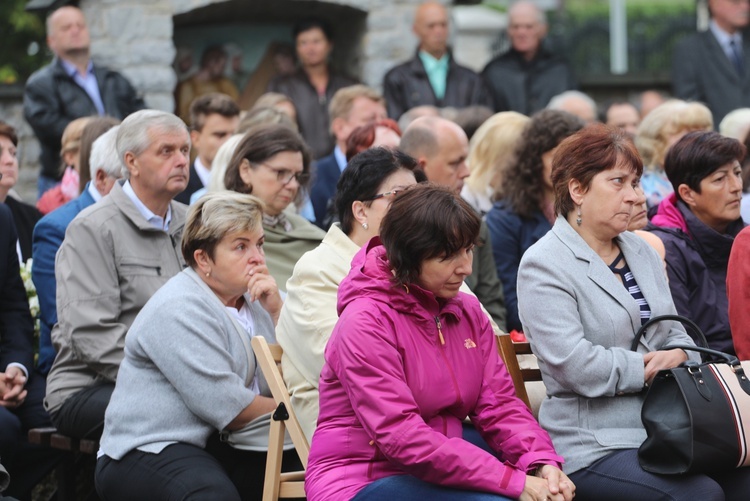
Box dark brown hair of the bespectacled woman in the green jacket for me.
[224,125,310,195]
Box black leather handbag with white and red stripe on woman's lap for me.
[631,315,750,474]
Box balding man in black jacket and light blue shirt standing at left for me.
[23,6,145,196]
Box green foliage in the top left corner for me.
[0,0,51,85]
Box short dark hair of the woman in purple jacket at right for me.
[664,131,747,200]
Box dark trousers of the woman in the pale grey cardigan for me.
[95,434,302,501]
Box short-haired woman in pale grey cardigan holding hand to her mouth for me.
[96,192,299,501]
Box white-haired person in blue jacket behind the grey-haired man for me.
[31,126,124,376]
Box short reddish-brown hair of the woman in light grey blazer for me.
[552,124,643,216]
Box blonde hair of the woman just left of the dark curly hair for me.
[466,111,531,193]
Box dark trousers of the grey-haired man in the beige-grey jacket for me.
[52,383,115,440]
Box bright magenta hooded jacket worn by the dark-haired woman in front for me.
[305,239,562,501]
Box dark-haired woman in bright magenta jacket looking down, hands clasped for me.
[305,185,575,501]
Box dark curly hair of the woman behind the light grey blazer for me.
[495,110,585,219]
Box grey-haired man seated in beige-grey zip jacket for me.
[44,110,190,438]
